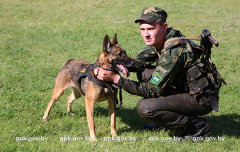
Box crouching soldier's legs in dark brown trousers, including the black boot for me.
[137,67,215,138]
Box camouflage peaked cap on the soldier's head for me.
[135,7,167,23]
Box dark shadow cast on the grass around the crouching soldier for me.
[95,107,240,138]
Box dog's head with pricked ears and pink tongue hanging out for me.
[99,34,134,77]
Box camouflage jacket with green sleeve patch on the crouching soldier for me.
[118,29,201,98]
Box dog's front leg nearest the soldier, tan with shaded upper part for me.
[108,98,118,137]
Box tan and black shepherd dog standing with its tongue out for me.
[42,34,134,141]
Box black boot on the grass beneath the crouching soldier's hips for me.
[181,116,211,141]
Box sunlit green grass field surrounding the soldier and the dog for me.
[0,0,240,151]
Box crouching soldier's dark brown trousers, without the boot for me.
[137,67,212,130]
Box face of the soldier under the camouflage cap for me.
[140,21,167,49]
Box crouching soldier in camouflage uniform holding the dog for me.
[98,7,221,139]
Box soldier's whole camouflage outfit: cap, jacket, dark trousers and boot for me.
[118,7,223,138]
